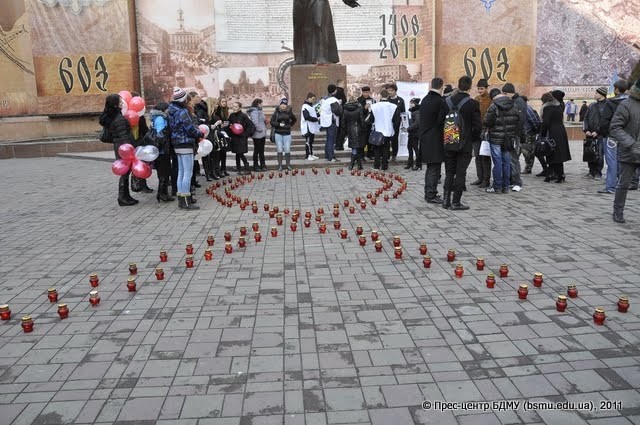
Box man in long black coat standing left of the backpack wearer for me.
[420,77,444,204]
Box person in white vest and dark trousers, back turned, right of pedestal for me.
[365,90,400,170]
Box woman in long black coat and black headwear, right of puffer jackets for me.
[540,93,571,183]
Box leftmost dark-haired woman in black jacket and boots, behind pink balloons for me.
[99,94,138,207]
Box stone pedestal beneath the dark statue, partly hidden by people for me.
[289,63,347,119]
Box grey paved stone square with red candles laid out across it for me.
[0,144,640,425]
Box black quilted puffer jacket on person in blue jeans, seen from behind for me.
[484,96,520,146]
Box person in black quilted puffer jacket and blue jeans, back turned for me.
[484,89,520,193]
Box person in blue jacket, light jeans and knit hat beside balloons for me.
[168,88,204,210]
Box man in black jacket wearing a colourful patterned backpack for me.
[441,75,482,210]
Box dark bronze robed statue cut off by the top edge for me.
[293,0,360,65]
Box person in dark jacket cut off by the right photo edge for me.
[611,80,640,223]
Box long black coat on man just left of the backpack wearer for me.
[418,91,444,164]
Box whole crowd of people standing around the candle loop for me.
[100,76,640,222]
